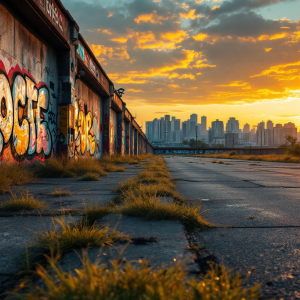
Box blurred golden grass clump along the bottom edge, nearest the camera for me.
[18,255,261,300]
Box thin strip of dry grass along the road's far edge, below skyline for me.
[196,153,300,163]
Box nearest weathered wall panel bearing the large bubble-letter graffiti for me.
[0,5,58,162]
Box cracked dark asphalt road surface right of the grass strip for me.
[165,156,300,299]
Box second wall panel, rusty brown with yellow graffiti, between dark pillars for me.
[68,81,103,158]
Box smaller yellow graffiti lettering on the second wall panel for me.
[75,101,101,156]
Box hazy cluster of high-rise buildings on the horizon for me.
[146,114,300,148]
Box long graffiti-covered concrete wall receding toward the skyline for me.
[0,0,153,163]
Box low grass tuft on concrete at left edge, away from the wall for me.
[0,191,47,211]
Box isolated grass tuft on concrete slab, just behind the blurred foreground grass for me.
[36,218,129,253]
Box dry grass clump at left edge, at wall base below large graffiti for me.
[0,163,34,194]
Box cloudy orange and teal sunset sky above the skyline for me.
[62,0,300,127]
